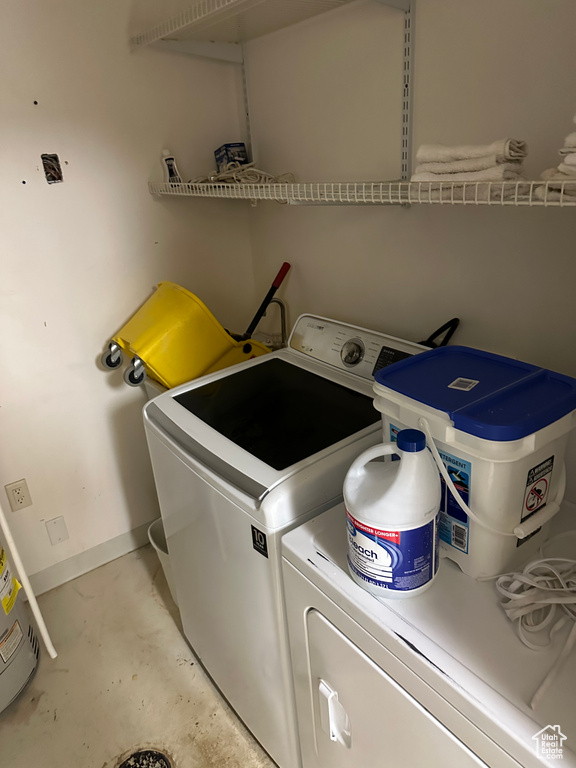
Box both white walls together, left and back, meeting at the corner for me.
[0,0,576,588]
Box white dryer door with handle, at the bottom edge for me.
[302,610,487,768]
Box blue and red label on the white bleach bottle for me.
[346,511,439,592]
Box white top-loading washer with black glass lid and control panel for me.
[144,315,425,768]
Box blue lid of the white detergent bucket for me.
[375,347,576,441]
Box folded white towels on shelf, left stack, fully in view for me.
[411,139,528,184]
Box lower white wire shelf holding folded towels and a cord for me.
[148,178,576,208]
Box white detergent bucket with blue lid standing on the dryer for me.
[374,347,576,578]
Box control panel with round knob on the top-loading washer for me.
[288,315,428,380]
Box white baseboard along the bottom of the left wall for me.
[29,523,150,595]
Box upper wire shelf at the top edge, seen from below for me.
[130,0,352,47]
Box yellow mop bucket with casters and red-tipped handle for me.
[102,265,290,389]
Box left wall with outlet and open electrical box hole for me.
[0,0,254,573]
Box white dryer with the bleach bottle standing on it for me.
[283,504,576,768]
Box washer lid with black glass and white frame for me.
[144,350,381,500]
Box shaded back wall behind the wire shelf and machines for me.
[248,0,576,499]
